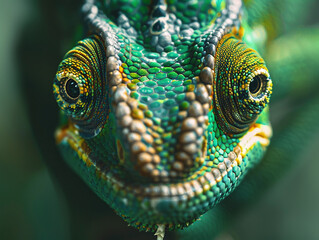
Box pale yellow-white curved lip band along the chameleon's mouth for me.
[55,123,272,197]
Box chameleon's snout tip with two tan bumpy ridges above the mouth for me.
[112,82,207,182]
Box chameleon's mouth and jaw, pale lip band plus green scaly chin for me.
[55,123,272,231]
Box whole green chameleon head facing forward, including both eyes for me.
[53,1,272,231]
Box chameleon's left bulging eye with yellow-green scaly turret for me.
[53,36,107,138]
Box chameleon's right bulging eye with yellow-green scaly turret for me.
[213,34,272,136]
